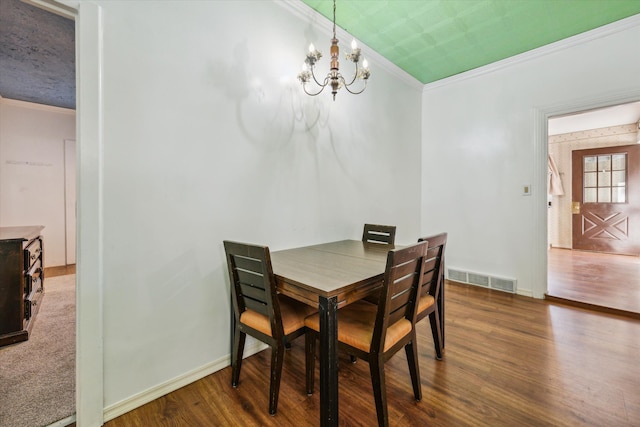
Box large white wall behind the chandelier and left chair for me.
[78,1,421,418]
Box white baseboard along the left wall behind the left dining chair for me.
[103,341,267,422]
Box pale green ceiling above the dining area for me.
[302,0,640,84]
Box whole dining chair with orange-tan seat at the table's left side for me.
[224,240,317,415]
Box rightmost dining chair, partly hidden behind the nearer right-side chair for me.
[416,233,447,360]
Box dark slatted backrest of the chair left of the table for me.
[224,240,284,340]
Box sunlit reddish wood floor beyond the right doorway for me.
[547,248,640,319]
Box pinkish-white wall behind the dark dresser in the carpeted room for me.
[0,98,76,267]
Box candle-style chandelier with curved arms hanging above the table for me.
[298,0,371,101]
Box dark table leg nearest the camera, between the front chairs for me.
[318,297,338,426]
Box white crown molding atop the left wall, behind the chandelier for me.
[273,0,424,90]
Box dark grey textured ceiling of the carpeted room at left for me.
[0,0,76,109]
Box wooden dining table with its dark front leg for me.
[271,240,400,426]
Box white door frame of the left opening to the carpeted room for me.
[25,0,104,426]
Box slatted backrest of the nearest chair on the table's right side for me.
[371,242,429,353]
